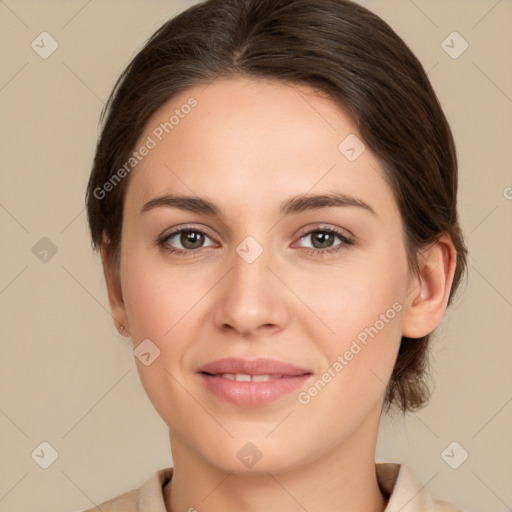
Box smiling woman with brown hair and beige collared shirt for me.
[83,0,466,512]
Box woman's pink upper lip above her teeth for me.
[198,357,311,376]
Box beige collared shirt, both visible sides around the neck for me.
[78,462,464,512]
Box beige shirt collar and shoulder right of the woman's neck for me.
[375,462,466,512]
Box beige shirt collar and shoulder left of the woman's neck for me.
[75,467,173,512]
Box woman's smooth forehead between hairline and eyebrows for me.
[122,79,390,220]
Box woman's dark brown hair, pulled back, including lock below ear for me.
[86,0,467,413]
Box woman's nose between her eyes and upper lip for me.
[214,242,289,337]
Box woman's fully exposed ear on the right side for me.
[402,234,457,338]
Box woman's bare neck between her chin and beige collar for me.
[164,410,387,512]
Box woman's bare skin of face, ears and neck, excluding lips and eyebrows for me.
[102,79,455,512]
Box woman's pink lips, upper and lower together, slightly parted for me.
[198,357,312,407]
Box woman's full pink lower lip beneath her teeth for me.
[198,373,311,407]
